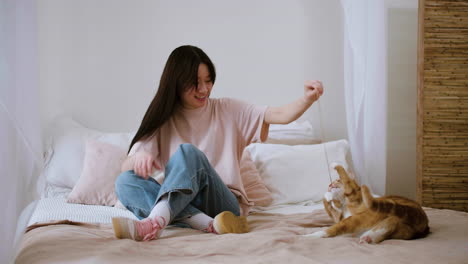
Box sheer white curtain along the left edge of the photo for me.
[0,0,43,263]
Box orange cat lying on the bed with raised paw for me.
[324,165,429,243]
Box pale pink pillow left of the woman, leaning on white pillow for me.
[67,140,127,206]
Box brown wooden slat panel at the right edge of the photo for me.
[417,0,468,211]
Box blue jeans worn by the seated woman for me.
[115,144,240,225]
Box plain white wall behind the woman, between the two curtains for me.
[38,0,346,142]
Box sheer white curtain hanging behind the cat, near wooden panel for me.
[341,0,387,195]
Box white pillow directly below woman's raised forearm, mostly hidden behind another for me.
[265,120,322,145]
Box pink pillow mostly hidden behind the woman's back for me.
[240,150,273,206]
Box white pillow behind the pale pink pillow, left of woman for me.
[44,118,135,189]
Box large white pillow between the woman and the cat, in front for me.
[247,140,349,205]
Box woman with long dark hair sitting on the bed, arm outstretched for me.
[112,46,323,241]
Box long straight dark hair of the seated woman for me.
[128,45,216,152]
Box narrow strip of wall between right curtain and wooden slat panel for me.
[386,6,418,199]
